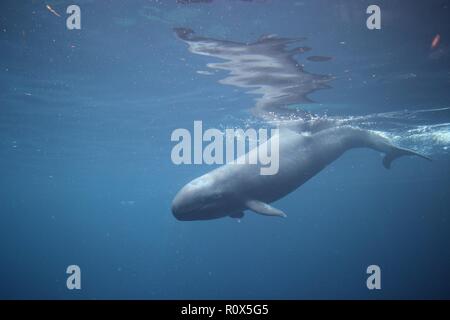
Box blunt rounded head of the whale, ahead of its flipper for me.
[172,174,228,221]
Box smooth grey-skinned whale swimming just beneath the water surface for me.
[172,126,429,220]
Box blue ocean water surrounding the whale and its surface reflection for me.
[0,0,450,299]
